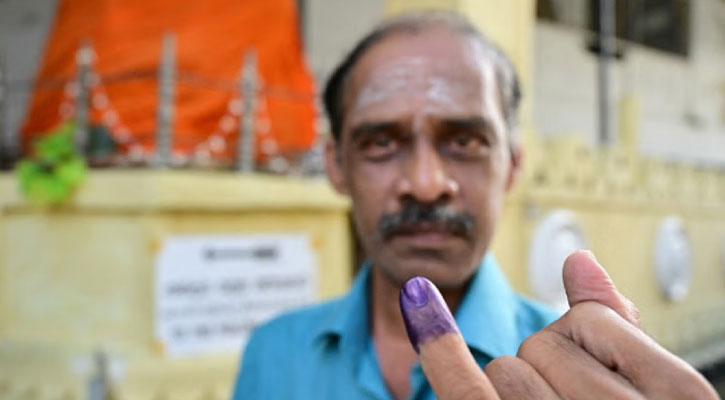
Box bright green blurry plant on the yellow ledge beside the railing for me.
[16,122,87,207]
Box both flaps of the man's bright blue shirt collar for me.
[312,254,518,358]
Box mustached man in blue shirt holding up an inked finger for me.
[234,12,714,400]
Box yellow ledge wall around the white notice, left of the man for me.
[0,171,352,400]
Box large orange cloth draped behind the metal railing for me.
[23,0,315,159]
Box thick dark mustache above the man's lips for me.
[378,201,475,240]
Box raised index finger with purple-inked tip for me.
[400,277,499,400]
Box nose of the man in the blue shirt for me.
[398,144,460,203]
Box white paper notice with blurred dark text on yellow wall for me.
[155,234,317,356]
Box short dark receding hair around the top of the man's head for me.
[322,10,521,143]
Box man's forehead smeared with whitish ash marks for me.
[343,28,498,119]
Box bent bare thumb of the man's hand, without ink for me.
[563,250,640,327]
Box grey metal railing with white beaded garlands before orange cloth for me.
[0,33,323,174]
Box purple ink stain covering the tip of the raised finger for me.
[400,276,458,353]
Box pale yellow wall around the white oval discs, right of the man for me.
[494,137,725,364]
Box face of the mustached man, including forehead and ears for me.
[328,29,518,288]
